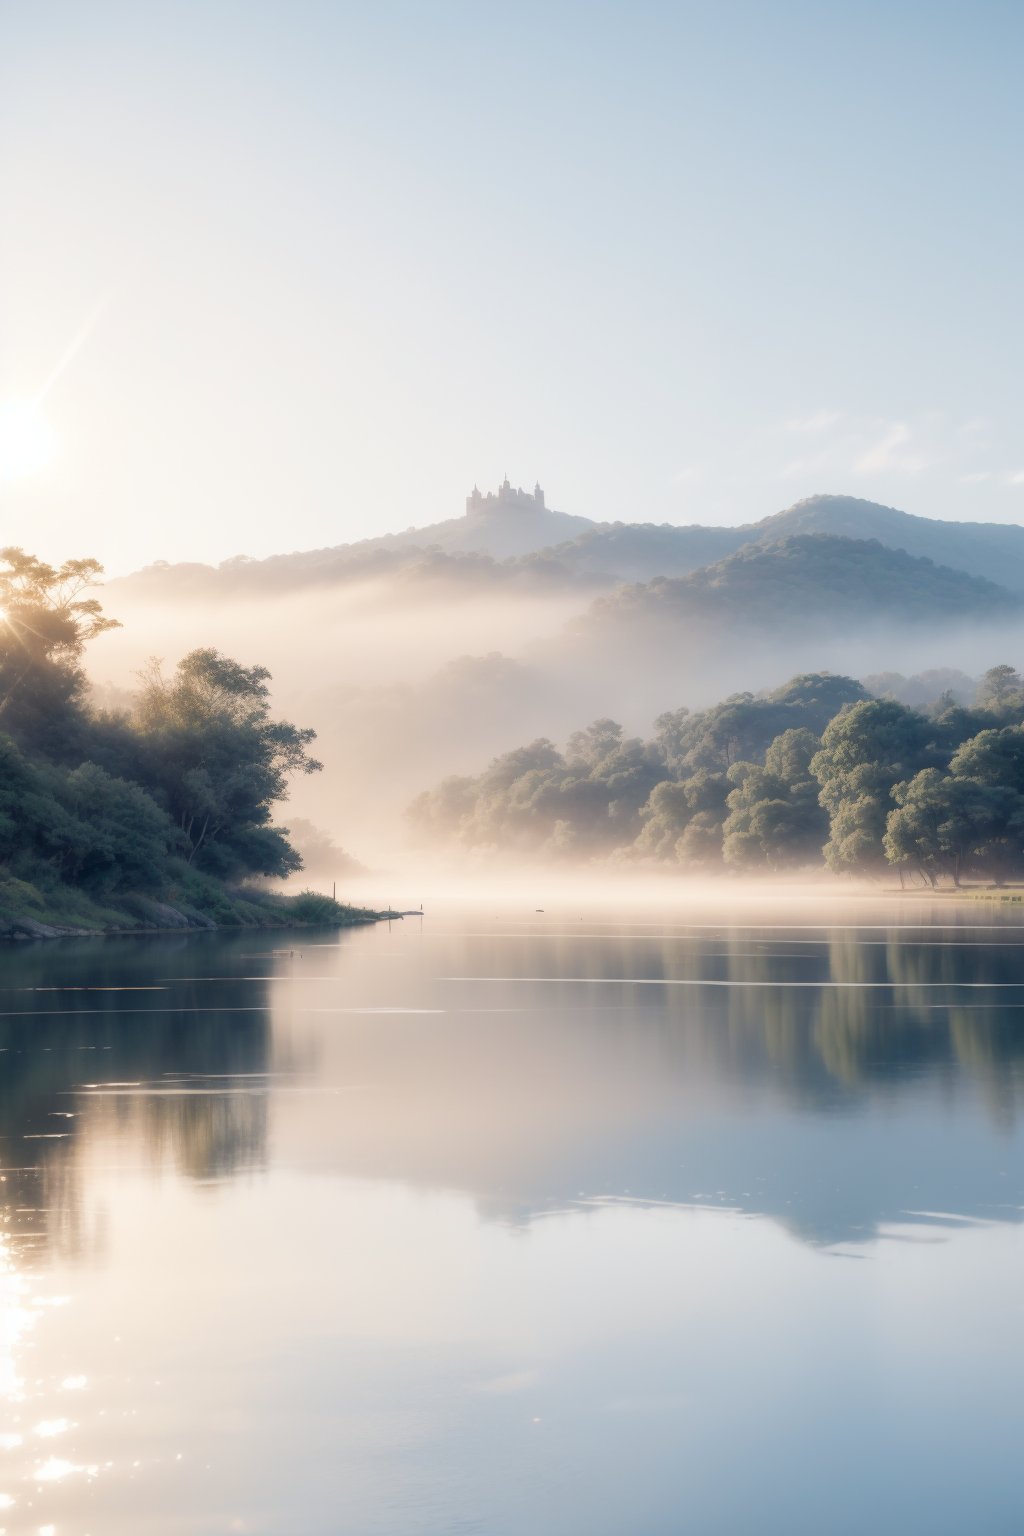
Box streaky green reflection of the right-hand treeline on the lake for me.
[500,925,1024,1121]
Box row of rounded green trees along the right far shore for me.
[408,667,1024,885]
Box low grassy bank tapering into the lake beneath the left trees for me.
[0,862,381,938]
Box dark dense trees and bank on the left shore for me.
[0,548,367,934]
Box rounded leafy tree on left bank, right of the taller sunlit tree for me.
[138,648,322,876]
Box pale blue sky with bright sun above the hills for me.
[0,0,1024,573]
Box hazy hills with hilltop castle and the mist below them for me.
[85,485,1024,856]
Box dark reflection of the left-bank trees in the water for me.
[0,935,269,1256]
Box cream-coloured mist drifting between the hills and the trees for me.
[91,551,1024,885]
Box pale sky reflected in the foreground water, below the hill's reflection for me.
[6,1169,1022,1536]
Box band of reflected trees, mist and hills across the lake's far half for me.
[0,920,1024,1256]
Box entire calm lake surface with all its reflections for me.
[0,900,1024,1536]
